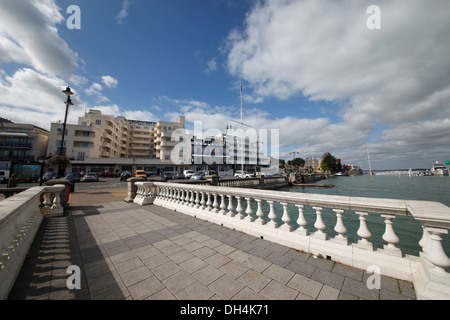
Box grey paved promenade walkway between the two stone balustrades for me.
[9,189,415,300]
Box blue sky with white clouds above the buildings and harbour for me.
[0,0,450,170]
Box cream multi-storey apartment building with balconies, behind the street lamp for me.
[47,109,185,172]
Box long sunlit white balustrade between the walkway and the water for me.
[134,182,450,299]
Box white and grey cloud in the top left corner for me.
[0,0,77,76]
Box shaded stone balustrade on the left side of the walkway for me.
[0,185,65,300]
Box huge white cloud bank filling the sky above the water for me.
[224,0,450,169]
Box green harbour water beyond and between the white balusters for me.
[275,175,450,257]
